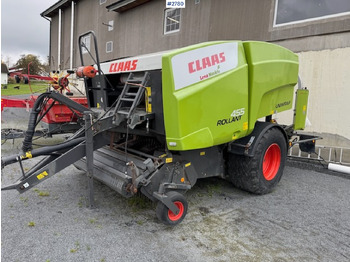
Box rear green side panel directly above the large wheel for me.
[243,41,299,132]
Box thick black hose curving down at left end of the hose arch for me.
[22,92,51,152]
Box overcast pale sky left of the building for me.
[1,0,59,66]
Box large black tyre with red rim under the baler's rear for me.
[227,128,287,194]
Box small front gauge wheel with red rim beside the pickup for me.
[156,191,188,226]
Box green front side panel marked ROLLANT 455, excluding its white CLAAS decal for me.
[162,42,248,150]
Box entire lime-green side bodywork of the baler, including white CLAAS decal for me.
[162,41,298,150]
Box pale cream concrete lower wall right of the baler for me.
[277,44,350,143]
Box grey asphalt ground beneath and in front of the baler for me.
[1,105,350,262]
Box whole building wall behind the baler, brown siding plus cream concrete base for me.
[45,0,350,144]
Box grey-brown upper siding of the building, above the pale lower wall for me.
[51,0,350,68]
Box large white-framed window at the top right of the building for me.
[274,0,350,26]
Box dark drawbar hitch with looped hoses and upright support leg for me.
[1,92,113,207]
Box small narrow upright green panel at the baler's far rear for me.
[294,89,309,130]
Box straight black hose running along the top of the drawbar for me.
[1,137,85,168]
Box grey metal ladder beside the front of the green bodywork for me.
[114,72,149,119]
